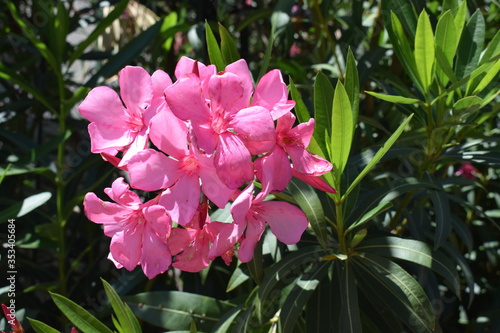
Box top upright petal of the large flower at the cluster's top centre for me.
[208,72,249,115]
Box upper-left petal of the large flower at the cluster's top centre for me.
[165,74,210,124]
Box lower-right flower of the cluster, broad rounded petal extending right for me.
[209,183,308,262]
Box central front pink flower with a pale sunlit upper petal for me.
[127,110,234,225]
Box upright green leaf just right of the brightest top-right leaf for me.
[435,11,458,86]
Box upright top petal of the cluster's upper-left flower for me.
[119,66,153,110]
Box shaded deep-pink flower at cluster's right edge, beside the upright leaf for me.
[255,112,336,193]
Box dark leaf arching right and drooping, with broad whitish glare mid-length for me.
[356,236,460,295]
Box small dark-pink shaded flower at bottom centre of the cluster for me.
[168,202,231,272]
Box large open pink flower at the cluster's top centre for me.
[165,60,281,189]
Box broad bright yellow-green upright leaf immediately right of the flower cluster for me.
[330,81,354,179]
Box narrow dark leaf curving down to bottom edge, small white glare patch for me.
[279,261,332,332]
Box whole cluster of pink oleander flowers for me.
[79,57,335,278]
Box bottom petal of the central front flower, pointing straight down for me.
[159,175,200,226]
